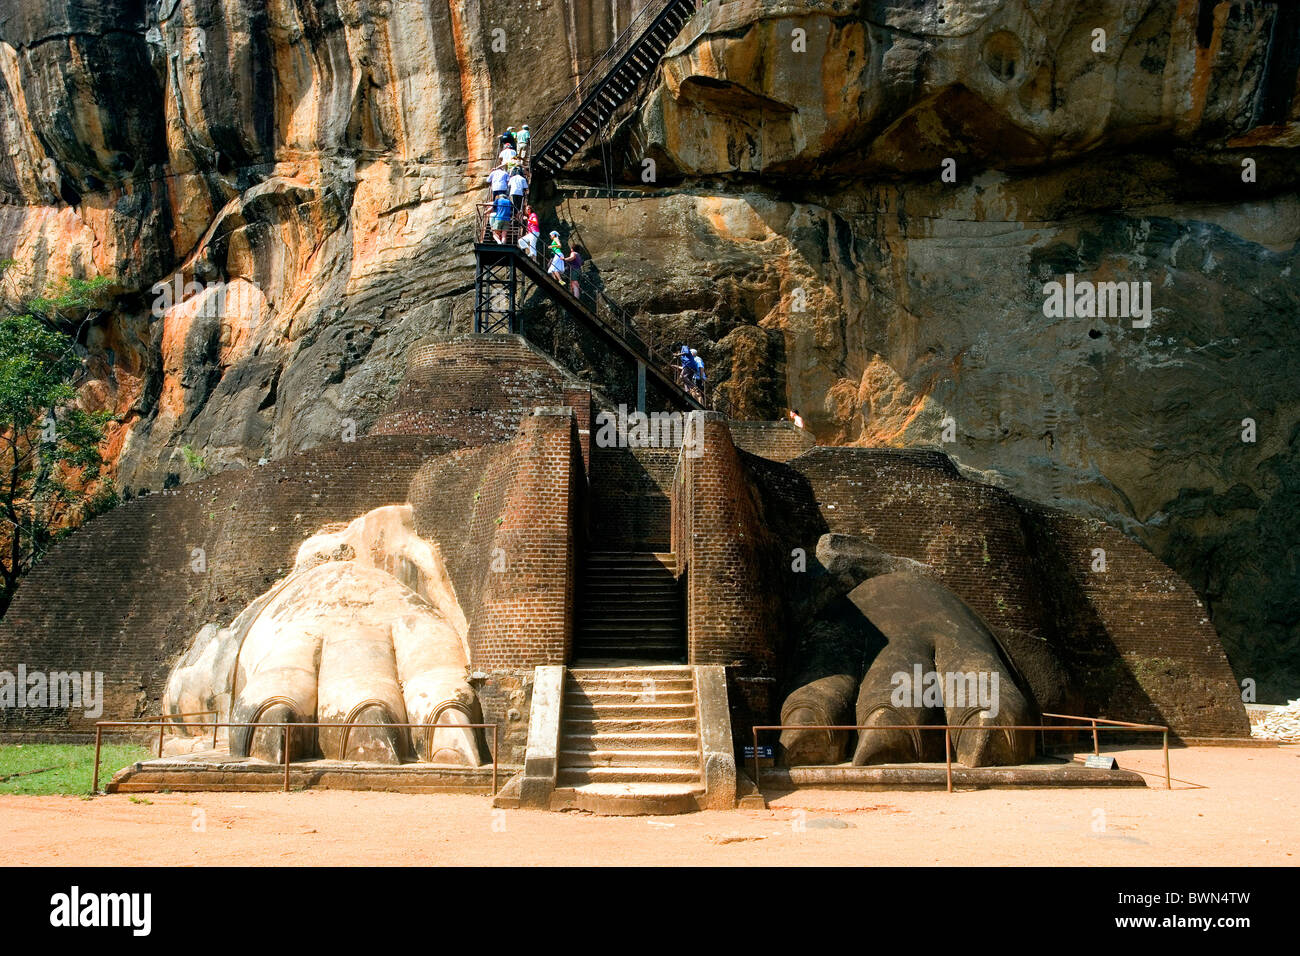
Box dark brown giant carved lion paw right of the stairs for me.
[781,571,1034,767]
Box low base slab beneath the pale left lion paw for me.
[105,750,517,793]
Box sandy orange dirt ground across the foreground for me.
[0,747,1300,866]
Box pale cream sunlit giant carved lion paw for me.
[164,506,482,766]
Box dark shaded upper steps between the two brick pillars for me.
[573,551,686,662]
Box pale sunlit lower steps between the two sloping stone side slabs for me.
[551,666,705,814]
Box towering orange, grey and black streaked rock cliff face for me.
[0,0,1300,698]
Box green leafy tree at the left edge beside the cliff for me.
[0,269,117,615]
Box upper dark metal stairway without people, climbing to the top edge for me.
[532,0,698,176]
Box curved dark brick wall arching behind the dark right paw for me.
[746,447,1247,736]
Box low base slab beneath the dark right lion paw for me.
[762,763,1147,791]
